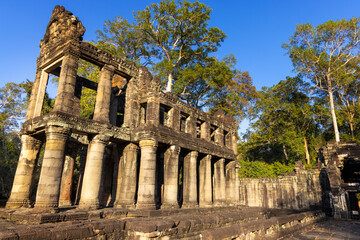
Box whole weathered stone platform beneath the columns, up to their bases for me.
[0,207,323,239]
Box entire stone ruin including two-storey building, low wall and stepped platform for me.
[0,6,332,240]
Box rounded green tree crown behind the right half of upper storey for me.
[174,55,257,120]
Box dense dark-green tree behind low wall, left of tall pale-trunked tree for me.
[245,77,322,164]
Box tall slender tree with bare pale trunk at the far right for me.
[283,18,360,142]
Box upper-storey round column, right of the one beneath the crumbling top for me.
[93,65,115,123]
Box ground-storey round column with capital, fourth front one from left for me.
[136,139,157,209]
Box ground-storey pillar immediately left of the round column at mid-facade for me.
[114,143,139,209]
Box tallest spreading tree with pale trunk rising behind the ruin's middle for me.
[98,0,225,92]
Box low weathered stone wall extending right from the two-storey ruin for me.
[239,168,321,209]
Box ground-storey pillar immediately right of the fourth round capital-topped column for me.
[162,145,180,208]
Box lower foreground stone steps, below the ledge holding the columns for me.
[0,207,324,240]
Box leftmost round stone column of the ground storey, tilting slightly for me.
[6,135,41,208]
